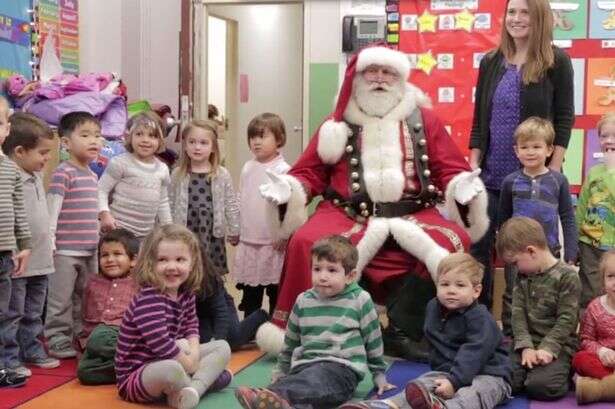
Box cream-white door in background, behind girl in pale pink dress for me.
[202,3,303,181]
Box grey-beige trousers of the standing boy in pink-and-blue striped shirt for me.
[45,254,98,349]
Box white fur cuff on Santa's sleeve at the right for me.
[444,172,489,243]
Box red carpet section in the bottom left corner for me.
[0,359,77,409]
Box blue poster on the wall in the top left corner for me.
[0,0,32,79]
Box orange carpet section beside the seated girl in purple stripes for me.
[12,347,262,409]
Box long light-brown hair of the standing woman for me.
[499,0,555,85]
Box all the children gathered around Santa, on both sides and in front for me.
[0,86,615,409]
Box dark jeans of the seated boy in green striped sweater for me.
[267,361,359,409]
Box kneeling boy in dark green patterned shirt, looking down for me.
[496,217,581,400]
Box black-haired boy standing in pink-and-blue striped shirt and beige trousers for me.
[45,112,102,358]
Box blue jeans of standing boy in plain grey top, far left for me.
[4,275,48,368]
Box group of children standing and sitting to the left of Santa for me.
[0,98,289,407]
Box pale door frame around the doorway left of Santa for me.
[191,0,310,147]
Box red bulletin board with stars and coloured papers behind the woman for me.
[386,0,615,192]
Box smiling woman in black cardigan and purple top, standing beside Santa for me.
[470,0,574,307]
